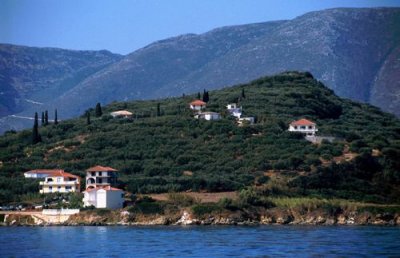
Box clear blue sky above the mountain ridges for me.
[0,0,400,54]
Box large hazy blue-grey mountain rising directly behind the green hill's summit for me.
[3,8,400,133]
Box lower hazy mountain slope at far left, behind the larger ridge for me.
[0,44,120,116]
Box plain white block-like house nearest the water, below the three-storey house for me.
[83,186,124,209]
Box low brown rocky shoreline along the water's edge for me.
[0,209,400,226]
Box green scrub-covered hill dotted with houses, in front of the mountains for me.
[0,72,400,203]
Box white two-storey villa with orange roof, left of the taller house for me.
[39,170,81,193]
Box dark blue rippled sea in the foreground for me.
[0,226,400,257]
